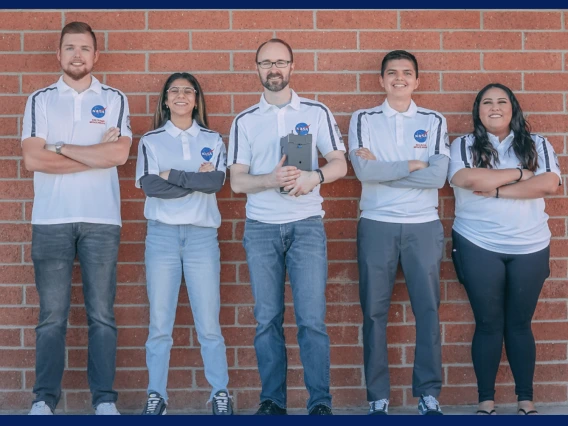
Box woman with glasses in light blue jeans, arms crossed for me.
[136,73,233,415]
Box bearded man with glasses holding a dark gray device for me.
[228,39,347,415]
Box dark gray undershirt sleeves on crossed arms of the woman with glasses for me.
[140,169,225,199]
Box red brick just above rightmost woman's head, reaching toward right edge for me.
[483,52,562,71]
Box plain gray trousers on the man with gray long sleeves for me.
[357,218,444,401]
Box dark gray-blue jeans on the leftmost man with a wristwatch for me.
[32,222,120,410]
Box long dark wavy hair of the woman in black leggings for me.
[471,83,538,172]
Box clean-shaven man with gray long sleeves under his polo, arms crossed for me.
[349,50,450,415]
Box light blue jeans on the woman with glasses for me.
[146,220,229,400]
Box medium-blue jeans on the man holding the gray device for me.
[243,216,331,410]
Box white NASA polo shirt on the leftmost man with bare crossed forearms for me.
[22,77,132,225]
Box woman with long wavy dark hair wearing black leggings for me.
[448,84,561,415]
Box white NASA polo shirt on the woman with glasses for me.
[136,120,227,228]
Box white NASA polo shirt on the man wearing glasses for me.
[228,90,345,224]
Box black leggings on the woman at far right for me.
[452,231,550,402]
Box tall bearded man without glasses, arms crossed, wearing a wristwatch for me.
[22,22,132,414]
